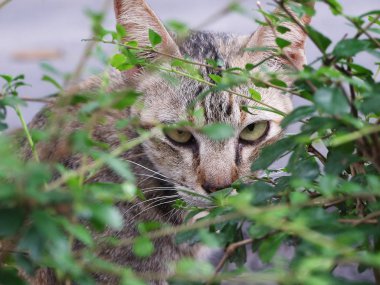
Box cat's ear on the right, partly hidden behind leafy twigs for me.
[247,1,314,68]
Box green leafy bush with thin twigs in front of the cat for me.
[0,0,380,285]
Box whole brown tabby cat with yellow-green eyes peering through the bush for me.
[24,0,310,285]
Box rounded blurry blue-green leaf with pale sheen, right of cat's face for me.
[314,87,350,115]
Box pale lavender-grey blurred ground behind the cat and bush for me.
[0,0,379,128]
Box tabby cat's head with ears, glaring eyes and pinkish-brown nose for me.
[115,0,310,205]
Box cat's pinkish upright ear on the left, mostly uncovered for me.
[114,0,180,59]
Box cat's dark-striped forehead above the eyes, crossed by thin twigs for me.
[138,32,291,126]
